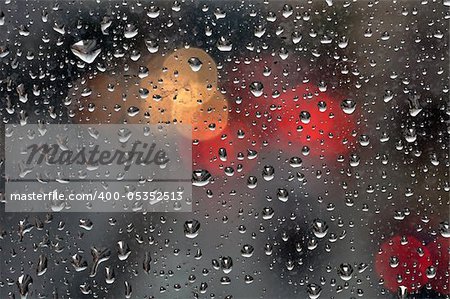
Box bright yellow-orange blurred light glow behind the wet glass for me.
[144,48,228,140]
